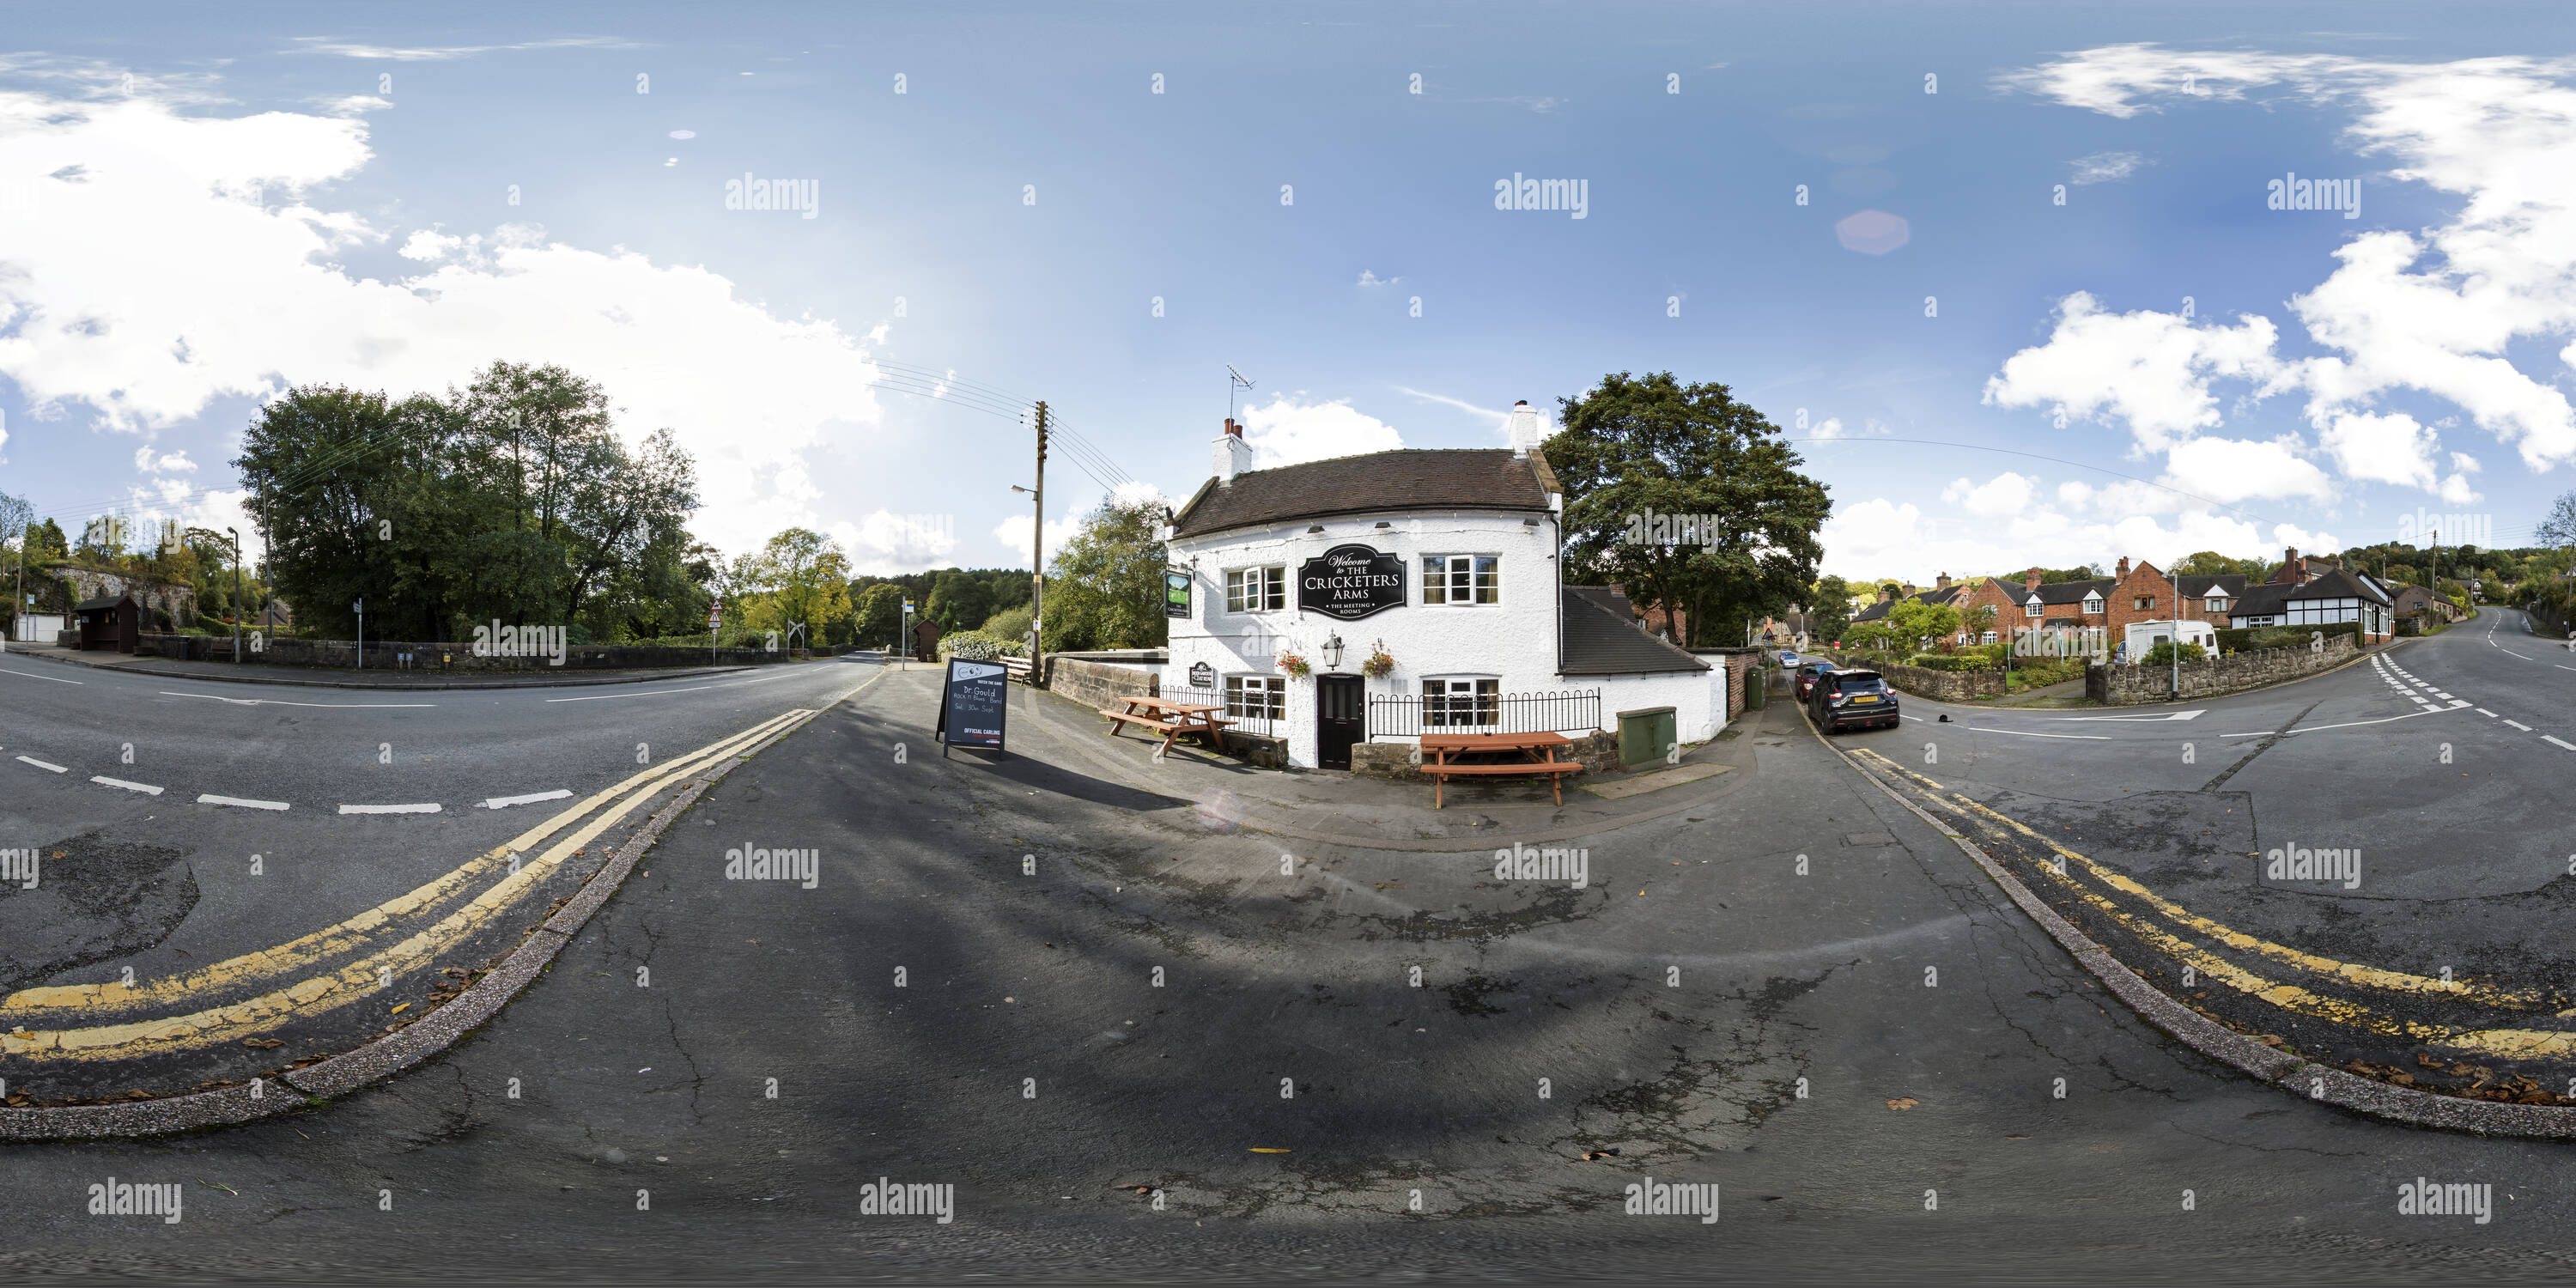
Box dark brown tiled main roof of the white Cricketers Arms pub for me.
[1172,448,1548,536]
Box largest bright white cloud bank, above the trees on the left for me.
[0,82,891,556]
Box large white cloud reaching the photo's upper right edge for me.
[2002,44,2576,477]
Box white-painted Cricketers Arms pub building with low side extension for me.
[1162,402,1726,768]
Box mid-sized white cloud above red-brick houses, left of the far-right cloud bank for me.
[1984,291,2280,451]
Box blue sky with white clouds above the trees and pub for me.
[0,3,2576,582]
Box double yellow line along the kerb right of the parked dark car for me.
[1850,747,2576,1059]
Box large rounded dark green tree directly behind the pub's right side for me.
[1546,371,1832,654]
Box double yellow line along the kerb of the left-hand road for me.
[0,708,817,1061]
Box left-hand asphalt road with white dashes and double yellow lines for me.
[0,654,876,1103]
